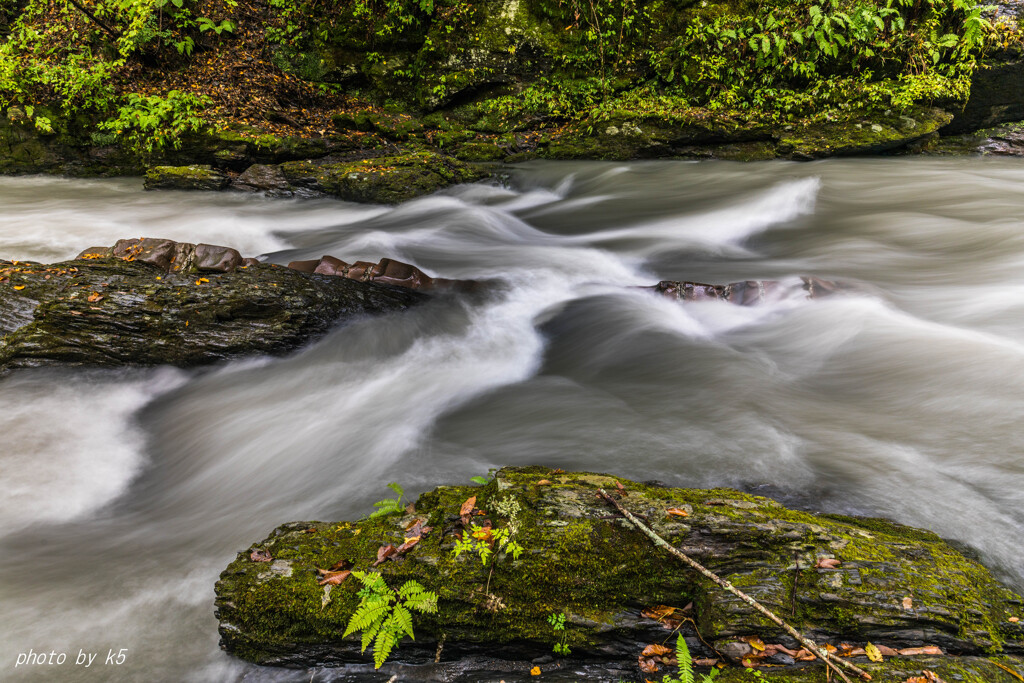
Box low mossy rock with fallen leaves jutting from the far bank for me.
[281,152,487,204]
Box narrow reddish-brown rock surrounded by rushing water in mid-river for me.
[643,276,854,306]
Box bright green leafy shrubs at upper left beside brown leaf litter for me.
[0,0,233,154]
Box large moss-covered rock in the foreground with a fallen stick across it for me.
[216,467,1024,683]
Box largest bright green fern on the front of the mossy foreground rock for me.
[343,571,437,669]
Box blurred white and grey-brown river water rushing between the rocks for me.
[0,159,1024,681]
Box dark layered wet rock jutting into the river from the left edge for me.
[0,239,425,370]
